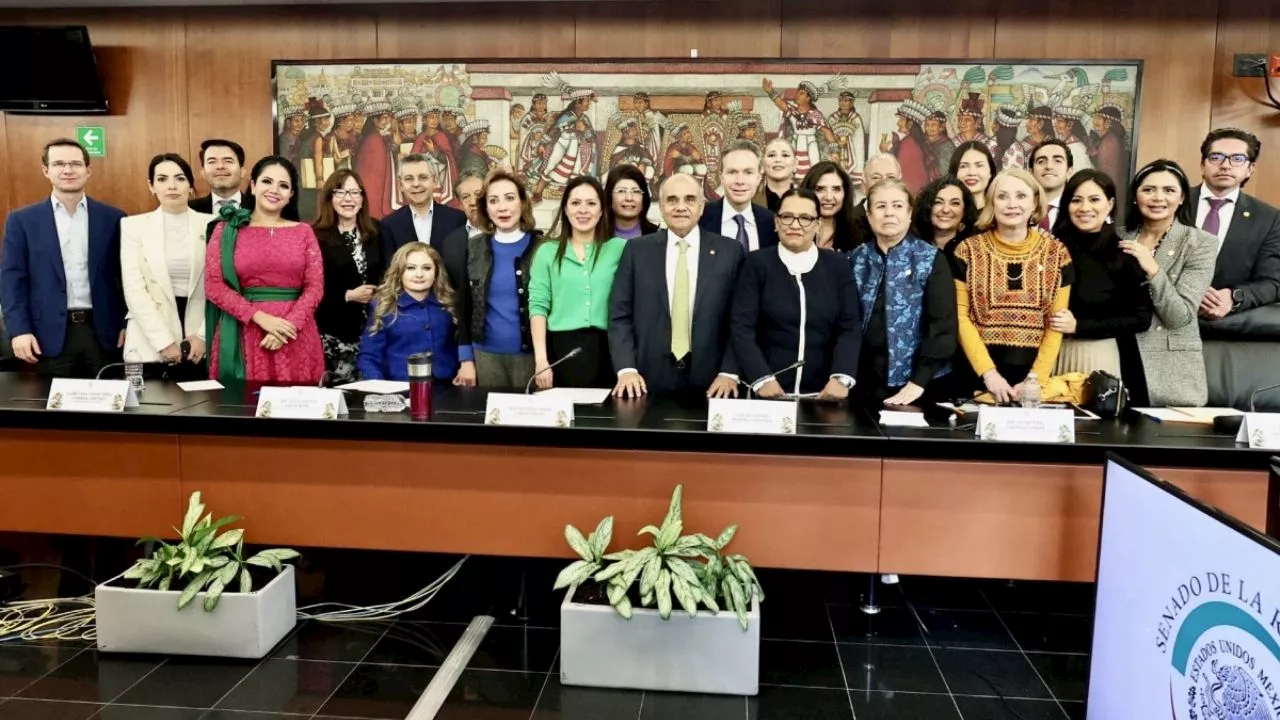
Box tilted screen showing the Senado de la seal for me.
[1085,456,1280,720]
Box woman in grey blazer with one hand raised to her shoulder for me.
[1120,160,1217,407]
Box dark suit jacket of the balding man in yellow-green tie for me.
[609,231,744,393]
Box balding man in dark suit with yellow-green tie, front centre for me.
[609,174,747,397]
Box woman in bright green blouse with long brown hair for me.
[529,176,626,389]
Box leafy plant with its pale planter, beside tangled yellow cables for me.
[93,492,298,659]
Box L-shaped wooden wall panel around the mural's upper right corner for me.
[995,0,1217,177]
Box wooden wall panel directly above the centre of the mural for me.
[573,0,790,58]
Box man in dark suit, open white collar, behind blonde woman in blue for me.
[383,154,467,262]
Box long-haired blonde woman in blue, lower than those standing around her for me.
[356,242,458,382]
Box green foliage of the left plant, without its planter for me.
[124,491,298,611]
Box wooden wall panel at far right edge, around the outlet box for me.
[1211,0,1280,205]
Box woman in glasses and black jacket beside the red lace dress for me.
[312,169,387,384]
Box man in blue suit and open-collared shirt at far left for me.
[0,138,125,378]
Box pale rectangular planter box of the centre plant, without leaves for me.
[561,588,760,696]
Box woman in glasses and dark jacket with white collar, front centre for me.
[730,188,863,400]
